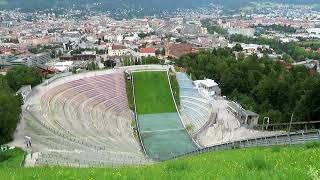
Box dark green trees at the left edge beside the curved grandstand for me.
[0,66,41,144]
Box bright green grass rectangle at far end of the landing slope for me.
[133,72,176,115]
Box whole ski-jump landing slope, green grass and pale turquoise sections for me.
[133,71,197,160]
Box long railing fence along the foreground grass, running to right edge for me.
[173,130,320,159]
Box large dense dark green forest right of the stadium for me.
[176,48,320,126]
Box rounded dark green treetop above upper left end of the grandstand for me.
[6,66,42,91]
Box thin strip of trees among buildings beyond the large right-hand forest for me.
[230,34,320,61]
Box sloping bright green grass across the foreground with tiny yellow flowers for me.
[0,144,320,180]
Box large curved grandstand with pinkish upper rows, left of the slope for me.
[23,70,151,167]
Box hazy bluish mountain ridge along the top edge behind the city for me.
[0,0,319,10]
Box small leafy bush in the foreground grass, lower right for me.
[246,154,272,170]
